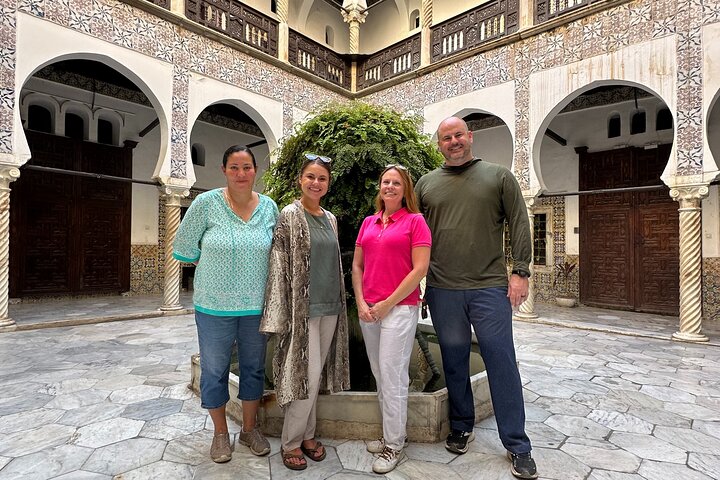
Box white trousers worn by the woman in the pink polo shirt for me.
[360,305,420,450]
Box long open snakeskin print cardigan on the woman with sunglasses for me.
[260,200,350,407]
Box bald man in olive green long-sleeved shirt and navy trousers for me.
[415,117,537,479]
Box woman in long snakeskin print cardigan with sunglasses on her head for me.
[260,154,350,470]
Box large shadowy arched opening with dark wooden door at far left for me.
[10,57,160,298]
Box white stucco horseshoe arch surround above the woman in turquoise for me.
[186,73,283,185]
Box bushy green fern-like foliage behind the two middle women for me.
[264,102,442,252]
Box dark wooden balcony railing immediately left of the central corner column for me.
[288,30,350,89]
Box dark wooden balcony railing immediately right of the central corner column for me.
[357,33,420,90]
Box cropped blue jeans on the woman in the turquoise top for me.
[195,311,267,409]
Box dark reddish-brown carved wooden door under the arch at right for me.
[580,145,679,315]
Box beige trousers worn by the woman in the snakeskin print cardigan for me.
[282,315,338,452]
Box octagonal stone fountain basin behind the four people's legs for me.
[191,325,493,443]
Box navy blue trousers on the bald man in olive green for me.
[425,287,532,453]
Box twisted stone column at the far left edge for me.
[0,165,20,331]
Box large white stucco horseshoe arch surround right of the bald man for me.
[528,36,677,192]
